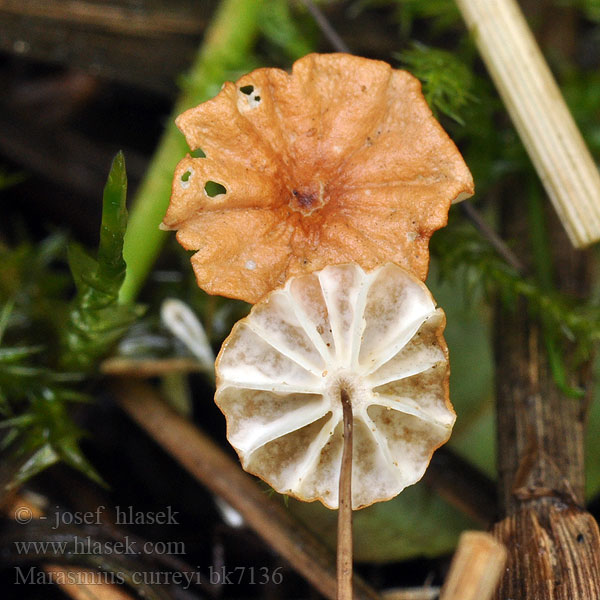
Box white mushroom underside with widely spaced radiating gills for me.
[215,264,455,508]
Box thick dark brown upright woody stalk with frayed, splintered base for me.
[493,103,600,600]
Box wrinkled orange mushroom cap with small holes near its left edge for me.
[162,54,473,303]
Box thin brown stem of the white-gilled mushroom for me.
[337,388,352,600]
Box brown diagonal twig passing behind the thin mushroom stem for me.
[115,380,379,600]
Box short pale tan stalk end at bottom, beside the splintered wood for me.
[440,531,506,600]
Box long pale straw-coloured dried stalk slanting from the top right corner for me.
[456,0,600,248]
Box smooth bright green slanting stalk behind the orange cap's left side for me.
[119,0,264,303]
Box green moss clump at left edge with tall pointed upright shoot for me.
[0,153,143,486]
